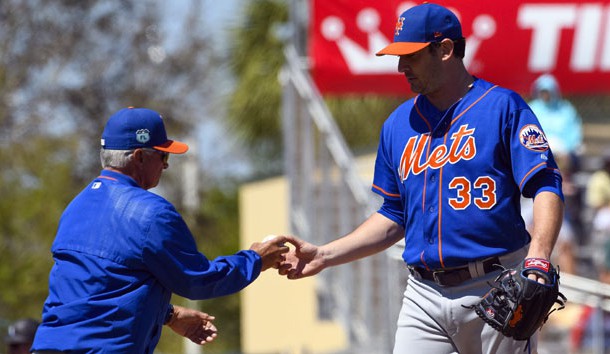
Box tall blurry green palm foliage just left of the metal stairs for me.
[228,0,288,175]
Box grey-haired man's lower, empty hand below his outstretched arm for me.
[167,305,218,345]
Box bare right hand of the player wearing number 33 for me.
[278,237,324,279]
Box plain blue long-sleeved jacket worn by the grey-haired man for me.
[32,170,261,353]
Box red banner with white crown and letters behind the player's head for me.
[309,0,610,95]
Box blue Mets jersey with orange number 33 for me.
[373,79,560,269]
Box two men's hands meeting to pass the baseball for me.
[250,235,323,279]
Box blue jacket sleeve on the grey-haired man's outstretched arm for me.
[143,205,261,300]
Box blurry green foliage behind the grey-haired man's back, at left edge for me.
[0,137,82,318]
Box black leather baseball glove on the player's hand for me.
[472,258,567,340]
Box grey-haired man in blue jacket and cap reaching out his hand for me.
[32,107,288,354]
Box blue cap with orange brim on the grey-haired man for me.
[101,107,189,154]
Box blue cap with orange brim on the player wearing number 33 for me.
[377,3,462,56]
